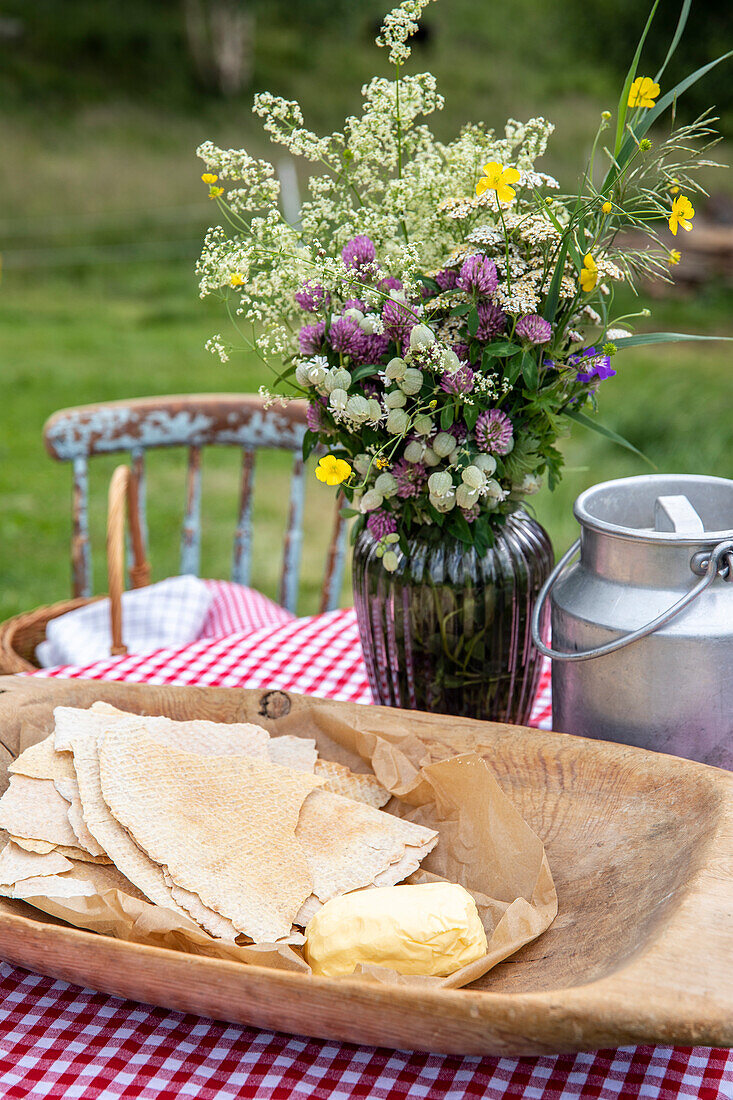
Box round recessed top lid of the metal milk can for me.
[573,474,733,546]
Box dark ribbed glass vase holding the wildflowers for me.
[353,512,553,725]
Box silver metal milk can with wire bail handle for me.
[533,474,733,769]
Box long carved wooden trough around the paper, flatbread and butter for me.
[0,677,733,1055]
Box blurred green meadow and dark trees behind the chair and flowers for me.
[0,0,733,618]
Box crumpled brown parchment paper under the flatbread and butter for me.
[5,706,557,988]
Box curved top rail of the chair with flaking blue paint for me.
[46,404,306,462]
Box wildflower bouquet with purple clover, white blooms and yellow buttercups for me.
[198,0,722,570]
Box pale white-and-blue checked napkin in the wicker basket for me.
[35,576,214,669]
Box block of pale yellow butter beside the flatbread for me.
[305,882,486,978]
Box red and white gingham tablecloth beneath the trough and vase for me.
[0,582,721,1100]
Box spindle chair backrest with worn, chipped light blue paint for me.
[43,394,347,612]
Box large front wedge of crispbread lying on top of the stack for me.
[99,729,322,943]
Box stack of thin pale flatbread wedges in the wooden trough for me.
[0,703,438,944]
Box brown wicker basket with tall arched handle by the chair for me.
[0,466,150,674]
